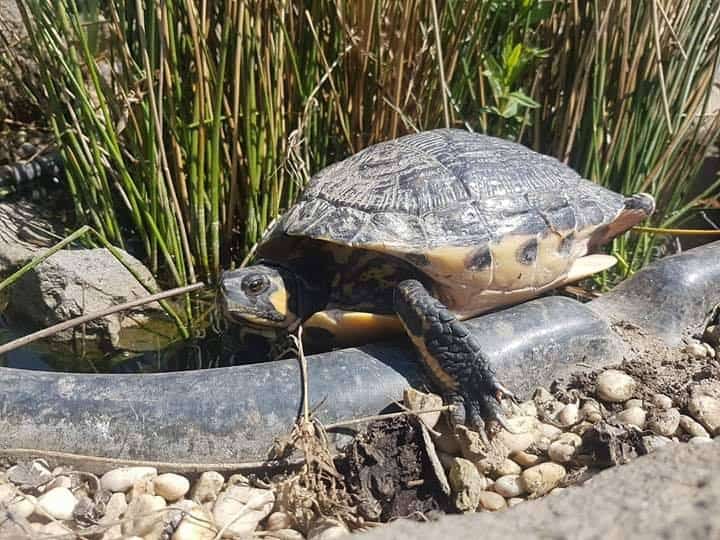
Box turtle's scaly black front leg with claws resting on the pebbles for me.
[394,279,513,436]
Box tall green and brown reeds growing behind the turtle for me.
[8,0,720,285]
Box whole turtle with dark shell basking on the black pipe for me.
[219,129,655,433]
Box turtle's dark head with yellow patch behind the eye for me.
[219,263,323,331]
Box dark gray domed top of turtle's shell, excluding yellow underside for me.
[271,129,624,249]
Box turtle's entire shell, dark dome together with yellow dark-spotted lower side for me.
[266,129,625,313]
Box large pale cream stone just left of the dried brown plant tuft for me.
[213,484,275,537]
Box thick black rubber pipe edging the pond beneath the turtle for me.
[0,242,720,463]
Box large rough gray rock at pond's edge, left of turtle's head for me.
[9,249,165,346]
